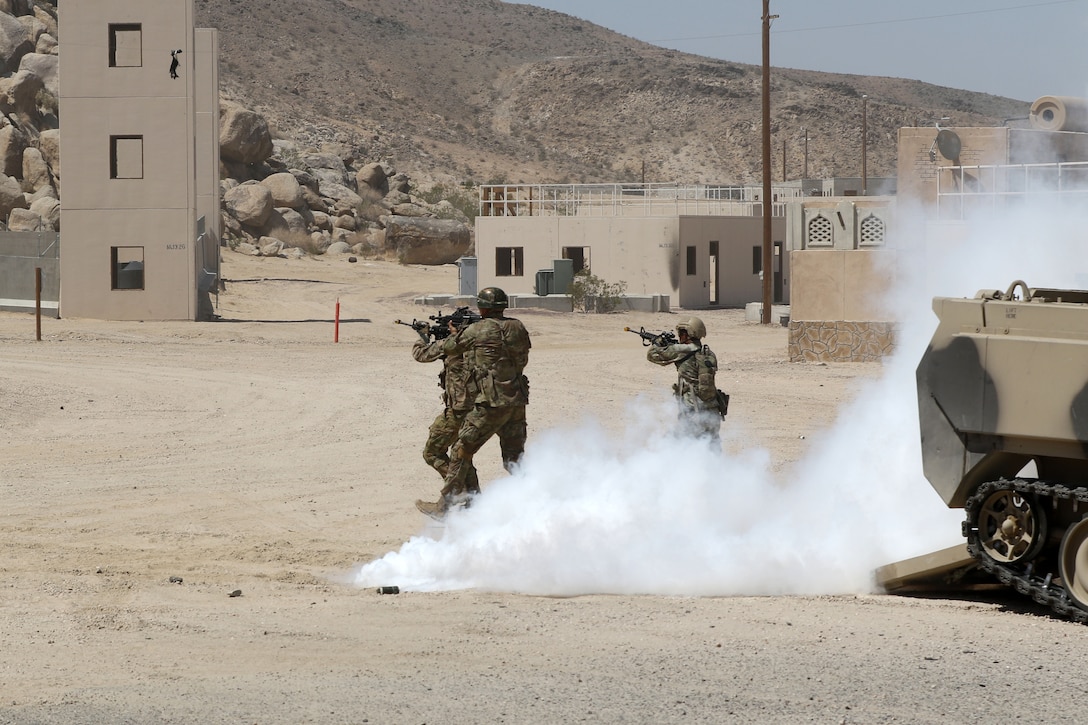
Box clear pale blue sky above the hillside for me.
[509,0,1088,101]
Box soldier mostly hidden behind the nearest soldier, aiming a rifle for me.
[411,323,480,493]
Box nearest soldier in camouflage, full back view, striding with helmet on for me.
[416,287,531,519]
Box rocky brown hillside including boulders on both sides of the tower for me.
[0,0,1028,252]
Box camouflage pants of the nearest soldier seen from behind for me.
[442,405,527,496]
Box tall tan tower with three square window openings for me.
[59,0,220,320]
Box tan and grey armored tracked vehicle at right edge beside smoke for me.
[917,281,1088,624]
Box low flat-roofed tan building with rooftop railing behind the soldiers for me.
[475,184,800,309]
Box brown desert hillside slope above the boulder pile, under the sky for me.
[196,0,1029,184]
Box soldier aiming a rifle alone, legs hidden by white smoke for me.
[646,317,728,441]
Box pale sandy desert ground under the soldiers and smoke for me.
[0,250,1088,723]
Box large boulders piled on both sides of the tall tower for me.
[0,0,472,265]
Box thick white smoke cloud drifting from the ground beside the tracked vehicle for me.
[351,194,1088,595]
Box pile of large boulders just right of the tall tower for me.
[220,101,472,265]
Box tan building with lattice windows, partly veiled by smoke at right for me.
[787,97,1088,361]
